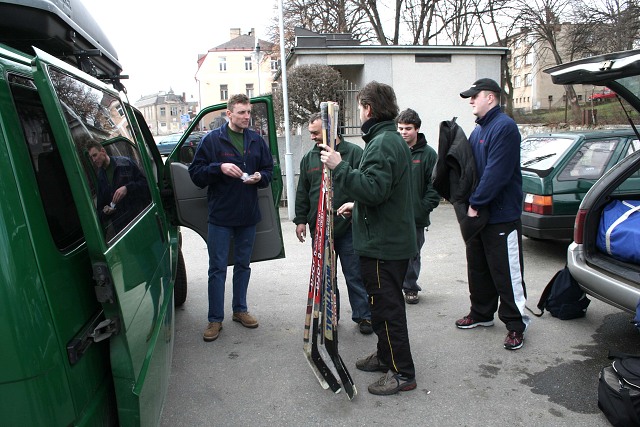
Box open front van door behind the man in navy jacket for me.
[165,96,284,265]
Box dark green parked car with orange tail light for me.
[521,127,638,239]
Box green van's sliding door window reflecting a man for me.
[49,67,151,243]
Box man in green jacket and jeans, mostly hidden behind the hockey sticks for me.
[293,113,373,335]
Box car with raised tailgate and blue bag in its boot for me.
[545,50,640,312]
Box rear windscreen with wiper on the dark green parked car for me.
[520,136,574,171]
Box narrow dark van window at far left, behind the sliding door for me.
[8,74,84,252]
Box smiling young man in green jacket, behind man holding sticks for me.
[396,108,440,304]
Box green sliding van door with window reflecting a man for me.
[34,49,173,425]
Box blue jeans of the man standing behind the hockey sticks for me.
[333,229,371,322]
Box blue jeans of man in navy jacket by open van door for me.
[207,224,256,322]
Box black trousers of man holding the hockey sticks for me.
[360,257,416,379]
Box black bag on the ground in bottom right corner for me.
[598,351,640,427]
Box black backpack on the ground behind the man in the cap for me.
[534,266,591,320]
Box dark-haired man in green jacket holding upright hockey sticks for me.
[320,81,418,395]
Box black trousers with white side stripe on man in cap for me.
[467,220,529,332]
